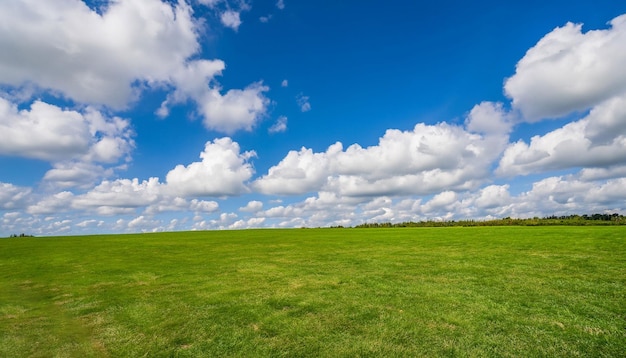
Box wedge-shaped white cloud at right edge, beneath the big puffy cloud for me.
[496,95,626,176]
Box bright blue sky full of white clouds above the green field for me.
[0,0,626,236]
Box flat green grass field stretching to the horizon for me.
[0,227,626,357]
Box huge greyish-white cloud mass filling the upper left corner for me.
[0,0,269,134]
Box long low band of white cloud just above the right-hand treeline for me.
[242,175,626,227]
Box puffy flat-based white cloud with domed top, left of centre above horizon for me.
[166,137,256,196]
